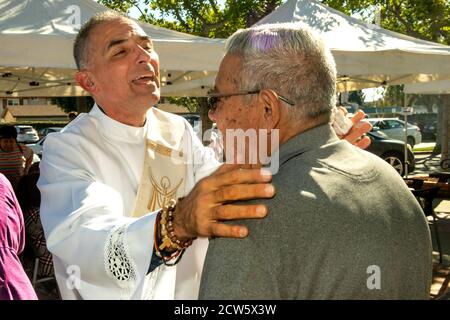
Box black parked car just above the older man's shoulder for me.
[366,132,416,176]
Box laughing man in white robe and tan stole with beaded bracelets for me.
[38,12,370,299]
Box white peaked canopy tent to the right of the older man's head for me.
[256,0,450,91]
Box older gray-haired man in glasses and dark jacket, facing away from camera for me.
[200,24,432,299]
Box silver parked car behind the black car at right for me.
[367,118,422,147]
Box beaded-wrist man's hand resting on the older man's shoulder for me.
[174,164,275,240]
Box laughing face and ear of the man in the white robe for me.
[76,18,160,123]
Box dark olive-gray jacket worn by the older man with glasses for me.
[200,125,432,299]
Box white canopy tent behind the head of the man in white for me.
[0,0,224,97]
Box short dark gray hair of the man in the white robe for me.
[73,11,129,70]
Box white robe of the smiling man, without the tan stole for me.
[38,105,218,299]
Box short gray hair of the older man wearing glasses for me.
[226,23,336,120]
